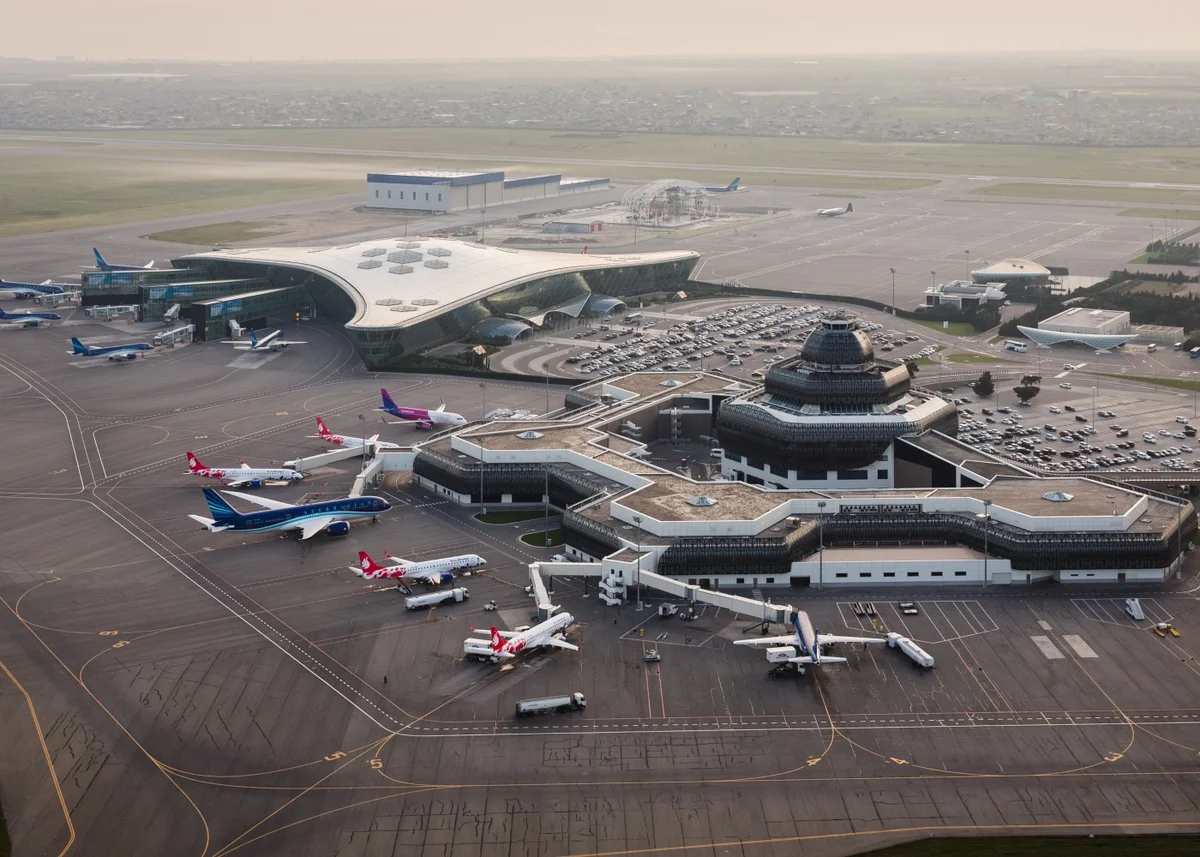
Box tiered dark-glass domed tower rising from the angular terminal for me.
[716,317,958,489]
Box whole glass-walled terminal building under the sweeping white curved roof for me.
[172,238,700,370]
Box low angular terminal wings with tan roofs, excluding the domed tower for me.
[383,360,1196,588]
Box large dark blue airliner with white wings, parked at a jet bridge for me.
[188,489,391,540]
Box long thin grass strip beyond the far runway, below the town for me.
[21,128,1200,184]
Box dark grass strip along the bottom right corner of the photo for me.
[862,834,1200,857]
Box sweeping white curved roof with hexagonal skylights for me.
[186,238,700,328]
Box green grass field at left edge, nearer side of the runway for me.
[0,150,362,238]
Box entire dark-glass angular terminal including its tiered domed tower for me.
[369,319,1196,588]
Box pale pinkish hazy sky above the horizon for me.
[9,0,1200,60]
